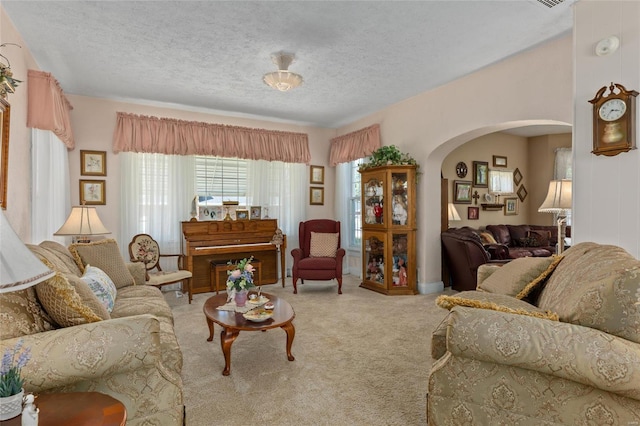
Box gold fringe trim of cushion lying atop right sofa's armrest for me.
[436,291,558,321]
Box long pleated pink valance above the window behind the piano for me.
[113,112,311,164]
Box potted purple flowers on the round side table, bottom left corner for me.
[0,339,31,420]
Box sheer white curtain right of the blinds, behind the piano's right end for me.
[247,160,307,272]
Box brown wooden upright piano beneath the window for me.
[182,219,287,294]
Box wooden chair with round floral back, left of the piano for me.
[129,234,193,303]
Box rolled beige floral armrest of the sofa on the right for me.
[447,306,640,400]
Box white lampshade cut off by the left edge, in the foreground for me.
[0,213,55,293]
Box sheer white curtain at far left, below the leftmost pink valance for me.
[31,129,71,245]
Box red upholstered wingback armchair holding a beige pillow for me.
[291,219,345,294]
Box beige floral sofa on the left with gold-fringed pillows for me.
[0,240,184,426]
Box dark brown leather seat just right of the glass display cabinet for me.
[441,226,510,291]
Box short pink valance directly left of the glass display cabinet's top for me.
[329,124,380,166]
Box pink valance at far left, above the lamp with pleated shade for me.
[27,70,75,149]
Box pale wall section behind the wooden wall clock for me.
[571,0,640,257]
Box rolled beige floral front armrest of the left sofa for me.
[0,314,161,392]
